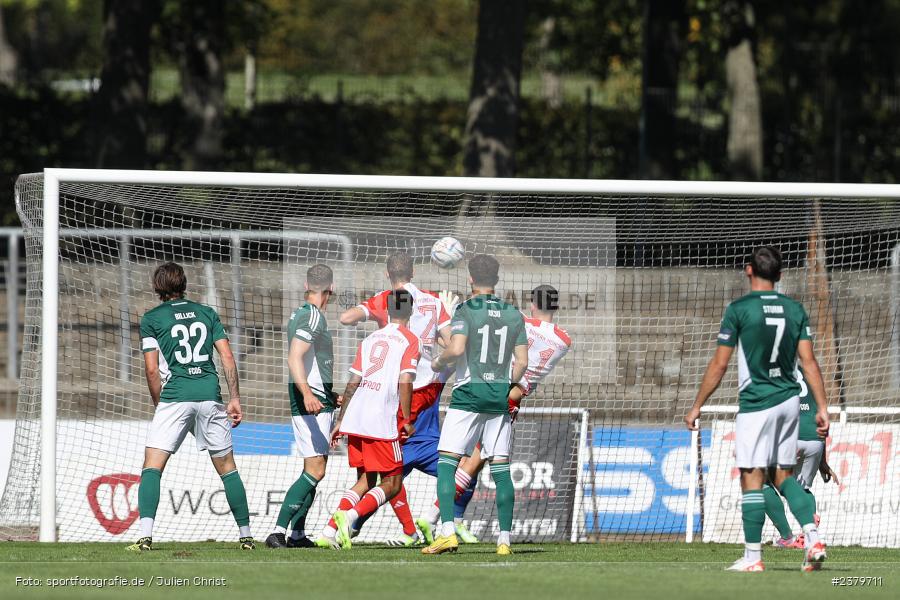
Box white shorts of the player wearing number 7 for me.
[734,396,800,469]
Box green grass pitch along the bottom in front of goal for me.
[0,542,900,600]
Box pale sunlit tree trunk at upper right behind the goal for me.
[722,0,763,180]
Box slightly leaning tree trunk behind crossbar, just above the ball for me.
[463,0,526,177]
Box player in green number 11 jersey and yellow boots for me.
[422,254,528,555]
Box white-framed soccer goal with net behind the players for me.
[0,169,900,547]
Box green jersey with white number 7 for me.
[718,291,812,413]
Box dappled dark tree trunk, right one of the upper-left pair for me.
[174,0,227,170]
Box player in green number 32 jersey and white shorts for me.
[128,262,255,552]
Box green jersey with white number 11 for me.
[450,294,528,414]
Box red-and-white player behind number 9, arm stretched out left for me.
[340,252,450,545]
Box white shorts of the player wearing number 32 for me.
[147,400,232,456]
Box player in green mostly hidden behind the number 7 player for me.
[763,366,840,549]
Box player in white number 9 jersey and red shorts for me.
[316,290,421,548]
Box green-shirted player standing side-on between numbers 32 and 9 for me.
[266,264,337,548]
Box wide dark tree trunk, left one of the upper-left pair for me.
[94,0,160,168]
